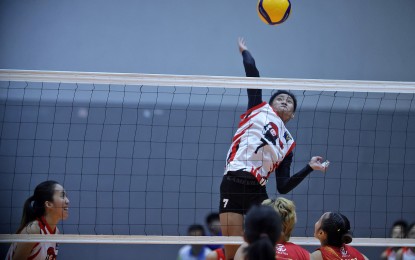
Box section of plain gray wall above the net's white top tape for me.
[0,0,415,81]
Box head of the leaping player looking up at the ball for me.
[269,90,297,123]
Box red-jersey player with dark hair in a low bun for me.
[311,212,368,260]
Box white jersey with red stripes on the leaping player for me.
[225,102,295,185]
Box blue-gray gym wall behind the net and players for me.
[0,0,415,259]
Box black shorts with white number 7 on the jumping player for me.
[219,171,268,215]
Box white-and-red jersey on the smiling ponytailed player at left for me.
[6,218,59,260]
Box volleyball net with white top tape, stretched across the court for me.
[0,70,415,246]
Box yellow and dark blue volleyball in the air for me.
[257,0,291,25]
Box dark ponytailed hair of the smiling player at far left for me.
[16,181,59,233]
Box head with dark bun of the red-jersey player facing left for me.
[314,212,352,247]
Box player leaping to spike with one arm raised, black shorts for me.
[219,39,327,259]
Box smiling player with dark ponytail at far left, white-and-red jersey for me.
[6,181,69,260]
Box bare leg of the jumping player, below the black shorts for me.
[219,212,244,260]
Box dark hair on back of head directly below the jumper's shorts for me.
[244,206,282,260]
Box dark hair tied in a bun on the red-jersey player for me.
[320,212,352,247]
